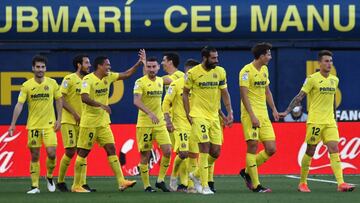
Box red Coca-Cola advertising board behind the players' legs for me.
[0,122,360,177]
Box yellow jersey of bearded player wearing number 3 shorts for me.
[185,64,227,120]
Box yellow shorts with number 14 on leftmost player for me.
[27,128,57,148]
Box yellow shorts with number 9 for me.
[77,125,115,150]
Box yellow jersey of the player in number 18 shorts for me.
[162,77,191,129]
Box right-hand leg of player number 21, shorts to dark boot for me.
[154,126,171,192]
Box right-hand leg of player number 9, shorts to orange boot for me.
[97,125,136,191]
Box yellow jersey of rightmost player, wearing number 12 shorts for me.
[301,72,339,124]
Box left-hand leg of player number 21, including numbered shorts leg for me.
[136,127,156,192]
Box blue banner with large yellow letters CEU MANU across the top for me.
[0,0,360,41]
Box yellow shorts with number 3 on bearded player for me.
[191,118,222,145]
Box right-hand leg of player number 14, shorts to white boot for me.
[42,128,57,192]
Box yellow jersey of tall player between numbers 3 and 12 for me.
[239,63,270,118]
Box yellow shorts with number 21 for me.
[136,126,171,152]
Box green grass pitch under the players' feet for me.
[0,175,360,203]
